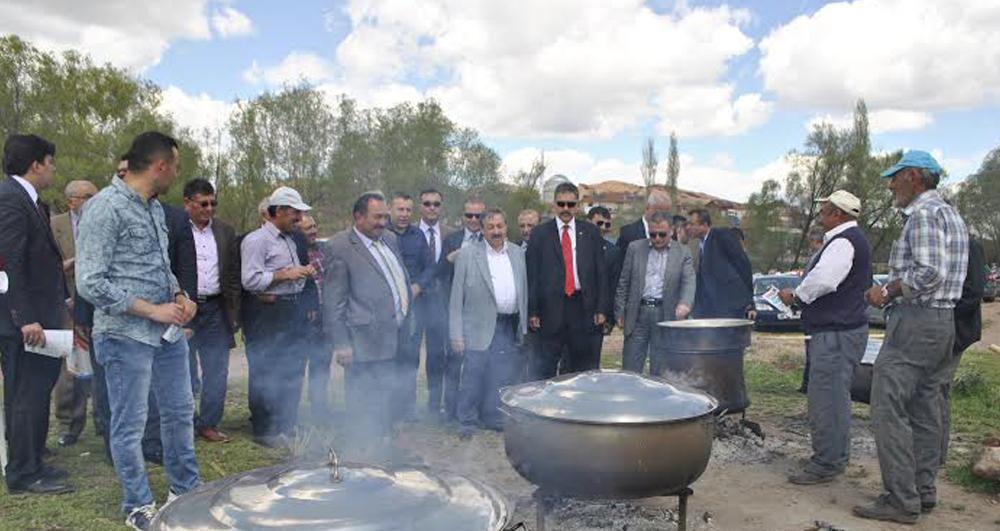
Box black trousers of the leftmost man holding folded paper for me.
[0,337,62,489]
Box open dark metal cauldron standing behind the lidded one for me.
[659,319,753,413]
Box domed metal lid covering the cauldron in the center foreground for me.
[500,371,719,424]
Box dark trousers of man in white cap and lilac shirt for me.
[244,298,307,436]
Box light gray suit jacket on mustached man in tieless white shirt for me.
[448,242,528,350]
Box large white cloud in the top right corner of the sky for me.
[760,0,1000,111]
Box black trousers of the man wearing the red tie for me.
[531,294,601,380]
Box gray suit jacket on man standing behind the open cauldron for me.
[615,239,697,336]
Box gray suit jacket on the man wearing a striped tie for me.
[323,227,413,362]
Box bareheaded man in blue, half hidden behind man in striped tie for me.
[389,193,436,421]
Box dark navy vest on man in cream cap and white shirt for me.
[802,227,872,334]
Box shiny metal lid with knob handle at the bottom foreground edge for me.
[152,463,510,531]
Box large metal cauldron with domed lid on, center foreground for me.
[501,371,718,499]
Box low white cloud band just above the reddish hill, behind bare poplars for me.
[502,147,792,201]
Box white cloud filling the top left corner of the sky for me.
[0,0,211,70]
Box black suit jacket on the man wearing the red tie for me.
[527,219,611,334]
